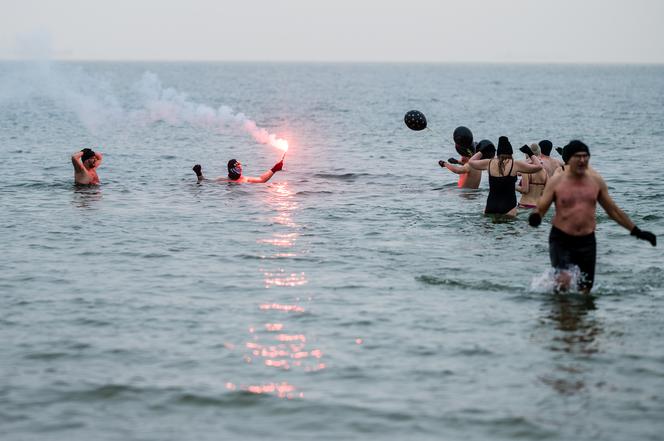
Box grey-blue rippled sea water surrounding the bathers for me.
[0,63,664,440]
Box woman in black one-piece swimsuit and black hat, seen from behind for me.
[468,136,542,217]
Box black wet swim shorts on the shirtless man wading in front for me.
[549,226,597,290]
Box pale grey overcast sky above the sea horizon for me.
[0,0,664,63]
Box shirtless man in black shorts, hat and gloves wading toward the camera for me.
[528,141,657,293]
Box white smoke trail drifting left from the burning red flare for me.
[0,63,288,151]
